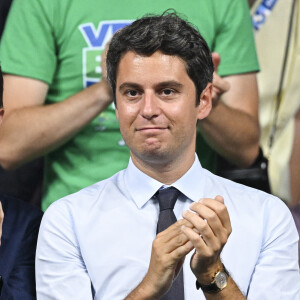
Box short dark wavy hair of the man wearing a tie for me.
[107,10,214,105]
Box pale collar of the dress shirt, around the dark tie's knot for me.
[124,154,205,208]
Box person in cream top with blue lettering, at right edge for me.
[249,0,300,206]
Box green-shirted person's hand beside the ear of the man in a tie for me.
[212,52,230,107]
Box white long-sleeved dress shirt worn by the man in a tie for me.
[36,157,300,300]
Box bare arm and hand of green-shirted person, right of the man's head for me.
[199,53,259,167]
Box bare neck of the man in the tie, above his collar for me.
[131,152,195,185]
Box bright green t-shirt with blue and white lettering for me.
[0,0,258,210]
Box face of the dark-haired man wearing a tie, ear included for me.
[116,51,211,163]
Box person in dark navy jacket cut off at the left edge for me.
[0,68,42,300]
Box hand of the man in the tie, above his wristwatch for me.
[182,196,232,284]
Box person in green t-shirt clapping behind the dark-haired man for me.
[0,0,259,210]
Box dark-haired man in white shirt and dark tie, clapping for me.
[36,13,300,300]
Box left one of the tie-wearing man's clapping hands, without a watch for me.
[141,220,194,299]
